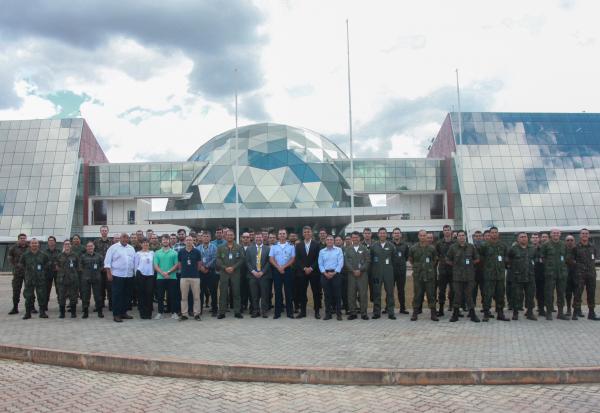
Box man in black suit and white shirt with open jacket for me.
[295,226,321,319]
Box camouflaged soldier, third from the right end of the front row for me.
[508,232,537,321]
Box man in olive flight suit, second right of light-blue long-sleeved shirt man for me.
[371,227,396,320]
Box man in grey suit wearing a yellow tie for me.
[246,232,271,318]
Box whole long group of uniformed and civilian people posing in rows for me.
[9,225,600,322]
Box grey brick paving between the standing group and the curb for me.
[0,277,600,368]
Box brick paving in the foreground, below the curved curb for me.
[0,361,600,413]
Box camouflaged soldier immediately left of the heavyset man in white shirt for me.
[79,241,104,318]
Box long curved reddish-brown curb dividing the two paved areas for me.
[0,345,600,385]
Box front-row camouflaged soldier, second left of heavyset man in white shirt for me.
[56,240,79,318]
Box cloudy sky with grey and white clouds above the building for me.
[0,0,600,162]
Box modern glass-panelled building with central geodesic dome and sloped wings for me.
[0,112,600,263]
